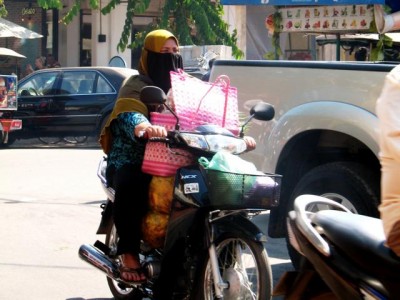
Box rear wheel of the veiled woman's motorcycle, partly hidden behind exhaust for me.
[105,224,145,300]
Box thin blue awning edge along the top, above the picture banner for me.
[221,0,385,6]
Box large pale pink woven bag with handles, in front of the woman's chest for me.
[170,70,239,134]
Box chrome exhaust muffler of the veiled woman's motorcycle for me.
[79,244,120,281]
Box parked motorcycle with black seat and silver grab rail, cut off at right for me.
[274,195,400,299]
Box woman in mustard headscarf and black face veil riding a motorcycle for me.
[100,29,183,282]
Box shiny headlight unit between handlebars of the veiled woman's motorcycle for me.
[181,133,247,154]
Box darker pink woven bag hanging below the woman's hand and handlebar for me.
[142,112,194,176]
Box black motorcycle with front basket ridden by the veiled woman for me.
[79,87,281,300]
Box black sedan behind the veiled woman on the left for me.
[13,67,138,144]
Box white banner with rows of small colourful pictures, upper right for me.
[275,5,374,32]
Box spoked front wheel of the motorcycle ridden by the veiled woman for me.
[194,233,272,300]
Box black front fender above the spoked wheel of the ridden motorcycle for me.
[213,215,267,243]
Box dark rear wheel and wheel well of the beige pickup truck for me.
[286,162,380,269]
